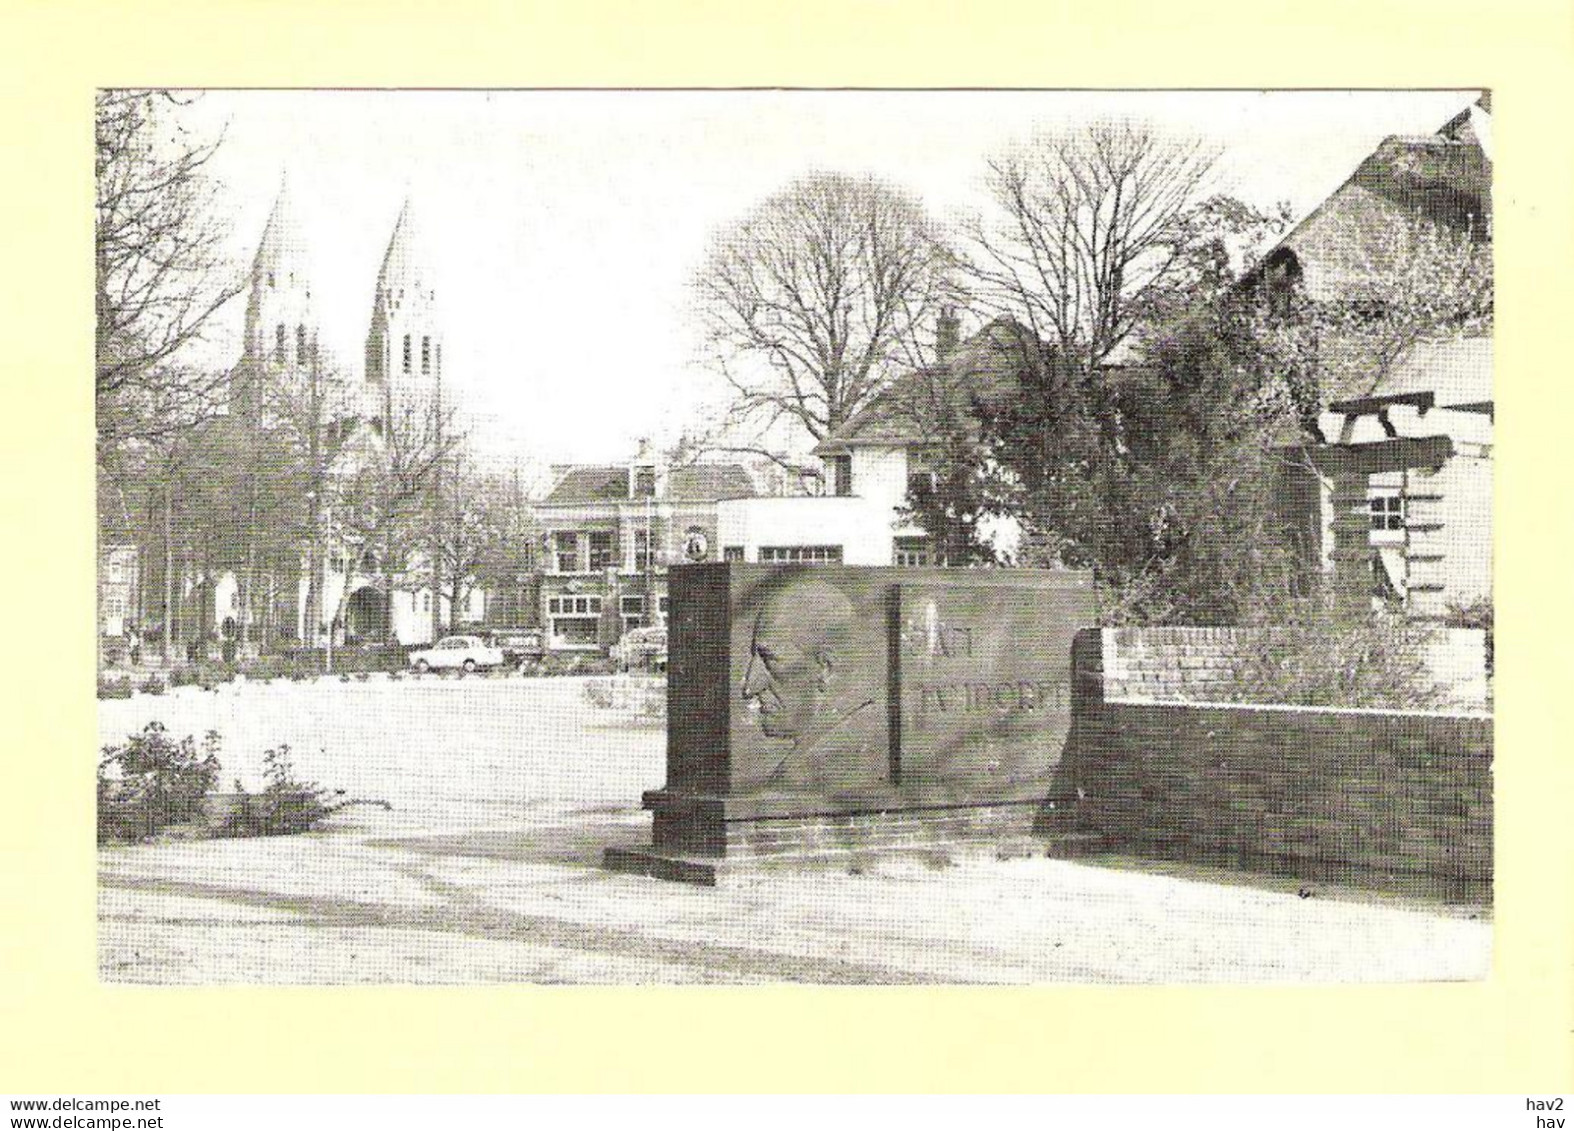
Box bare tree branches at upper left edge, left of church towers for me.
[94,90,241,451]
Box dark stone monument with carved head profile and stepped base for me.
[604,562,1096,882]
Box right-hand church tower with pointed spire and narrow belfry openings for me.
[367,200,442,433]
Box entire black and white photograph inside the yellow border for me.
[92,87,1508,986]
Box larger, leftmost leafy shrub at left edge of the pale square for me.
[98,722,219,842]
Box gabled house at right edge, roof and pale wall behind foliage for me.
[1248,94,1494,621]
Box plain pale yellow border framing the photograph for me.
[0,0,1574,1093]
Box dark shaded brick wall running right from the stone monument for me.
[1061,629,1492,892]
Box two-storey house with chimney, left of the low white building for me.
[532,450,756,653]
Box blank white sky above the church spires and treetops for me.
[169,91,1478,473]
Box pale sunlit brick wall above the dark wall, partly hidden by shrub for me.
[1102,628,1489,711]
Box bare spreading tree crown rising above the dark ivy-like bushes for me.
[968,123,1221,379]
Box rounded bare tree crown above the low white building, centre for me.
[696,173,951,458]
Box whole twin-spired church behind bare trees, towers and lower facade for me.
[181,186,483,650]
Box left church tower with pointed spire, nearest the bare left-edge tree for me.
[230,181,318,418]
